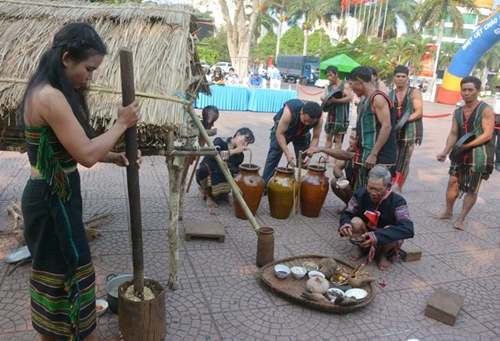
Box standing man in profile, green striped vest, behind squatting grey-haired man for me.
[349,66,397,191]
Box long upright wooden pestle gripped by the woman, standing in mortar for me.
[120,49,144,298]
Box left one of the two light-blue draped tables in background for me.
[194,85,248,111]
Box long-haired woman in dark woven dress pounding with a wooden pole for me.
[19,22,141,341]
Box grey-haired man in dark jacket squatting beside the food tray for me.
[339,166,414,270]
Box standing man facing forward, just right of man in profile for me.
[389,65,423,193]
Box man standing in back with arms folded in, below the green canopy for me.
[320,65,352,165]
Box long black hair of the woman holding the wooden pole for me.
[17,22,108,138]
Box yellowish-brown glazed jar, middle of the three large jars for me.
[267,167,299,219]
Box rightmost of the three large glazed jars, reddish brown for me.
[300,165,329,218]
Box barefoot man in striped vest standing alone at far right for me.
[433,76,495,230]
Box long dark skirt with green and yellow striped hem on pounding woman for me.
[22,171,96,340]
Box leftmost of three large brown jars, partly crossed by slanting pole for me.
[233,163,264,220]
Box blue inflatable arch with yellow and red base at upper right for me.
[437,8,500,104]
